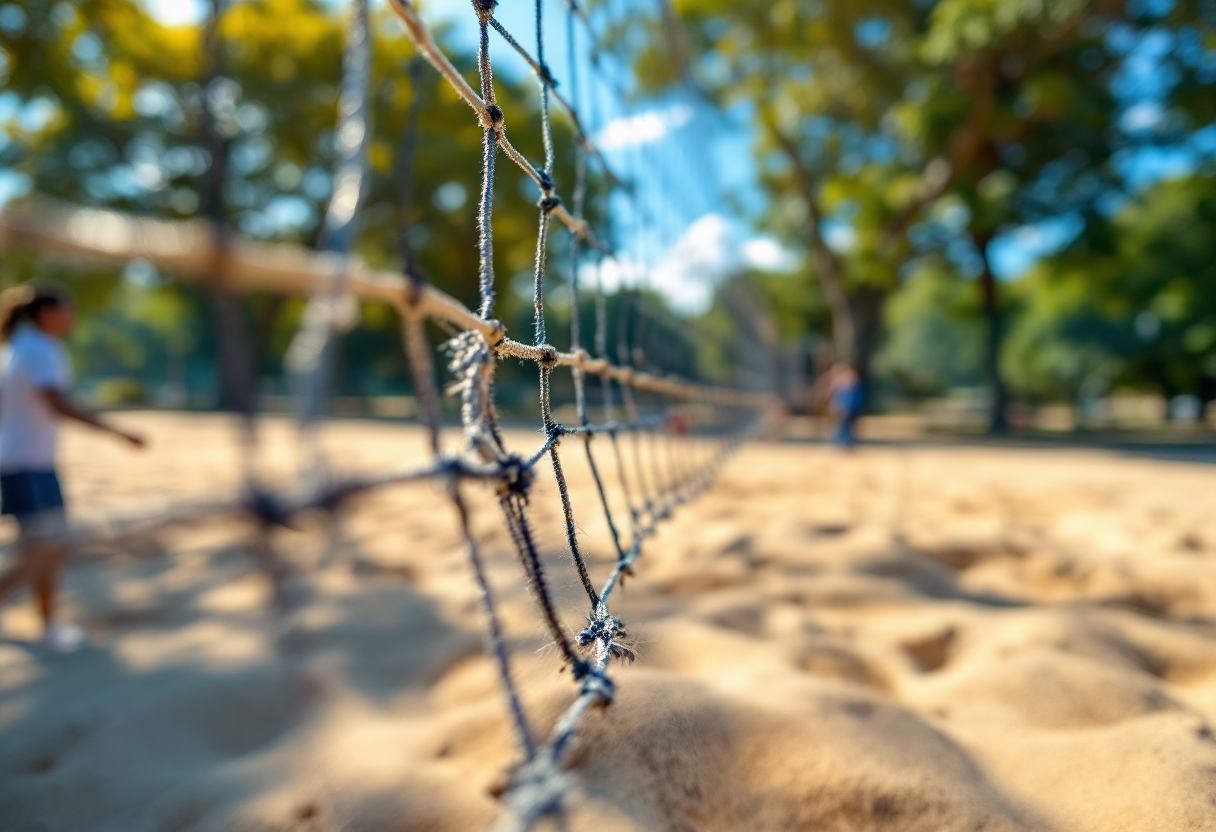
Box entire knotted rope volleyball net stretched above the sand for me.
[0,0,772,831]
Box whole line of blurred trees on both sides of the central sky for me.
[0,0,1216,429]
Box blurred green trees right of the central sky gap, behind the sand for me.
[620,0,1216,431]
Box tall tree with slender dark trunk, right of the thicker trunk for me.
[910,0,1186,432]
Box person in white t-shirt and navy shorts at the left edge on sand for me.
[0,282,143,652]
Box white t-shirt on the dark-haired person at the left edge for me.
[0,326,72,473]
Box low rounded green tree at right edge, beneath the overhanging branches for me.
[1006,173,1216,399]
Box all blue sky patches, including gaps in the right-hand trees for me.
[33,0,1216,295]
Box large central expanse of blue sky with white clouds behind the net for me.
[138,0,753,311]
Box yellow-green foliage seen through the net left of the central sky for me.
[0,0,596,399]
